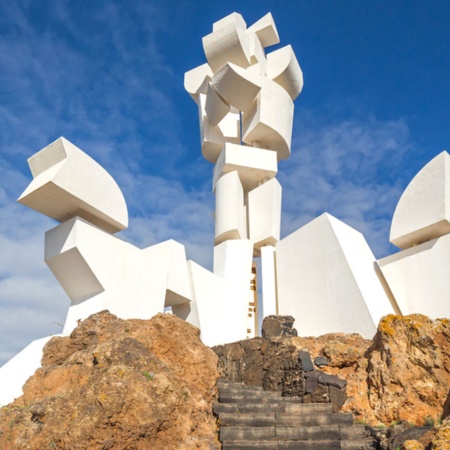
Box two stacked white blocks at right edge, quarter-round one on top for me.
[379,152,450,318]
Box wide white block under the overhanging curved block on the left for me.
[45,218,192,333]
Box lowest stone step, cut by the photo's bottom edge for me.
[222,440,340,450]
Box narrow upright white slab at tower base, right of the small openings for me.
[261,245,278,317]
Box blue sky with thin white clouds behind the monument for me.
[0,0,450,364]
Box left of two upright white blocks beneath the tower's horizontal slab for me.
[214,171,247,245]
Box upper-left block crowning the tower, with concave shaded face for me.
[202,13,250,73]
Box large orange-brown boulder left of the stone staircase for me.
[0,312,220,450]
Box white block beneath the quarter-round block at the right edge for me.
[378,224,450,319]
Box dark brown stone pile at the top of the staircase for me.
[213,316,347,412]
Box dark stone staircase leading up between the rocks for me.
[213,380,377,450]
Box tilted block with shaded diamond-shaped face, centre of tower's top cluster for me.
[211,63,261,111]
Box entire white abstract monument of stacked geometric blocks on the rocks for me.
[0,13,450,406]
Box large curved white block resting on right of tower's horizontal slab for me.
[242,79,294,159]
